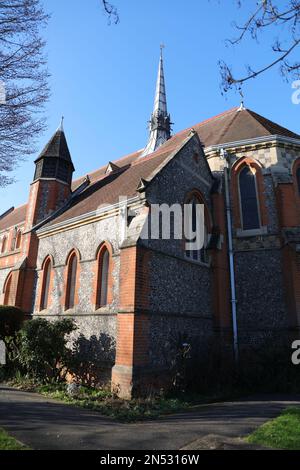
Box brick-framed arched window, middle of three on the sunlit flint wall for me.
[64,249,80,310]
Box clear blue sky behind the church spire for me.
[0,0,300,213]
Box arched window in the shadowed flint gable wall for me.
[185,195,209,263]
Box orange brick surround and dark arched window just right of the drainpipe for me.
[231,157,268,230]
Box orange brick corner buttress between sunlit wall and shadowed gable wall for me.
[112,246,150,398]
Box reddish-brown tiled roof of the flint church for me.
[0,108,300,230]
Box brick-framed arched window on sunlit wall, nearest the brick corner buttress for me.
[93,242,113,310]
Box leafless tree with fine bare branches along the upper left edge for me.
[0,0,49,186]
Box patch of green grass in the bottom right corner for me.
[247,408,300,450]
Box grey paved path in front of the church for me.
[0,385,300,450]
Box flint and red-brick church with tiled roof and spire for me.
[0,50,300,397]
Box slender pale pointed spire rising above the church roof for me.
[141,45,171,157]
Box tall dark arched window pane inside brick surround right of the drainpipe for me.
[239,165,260,230]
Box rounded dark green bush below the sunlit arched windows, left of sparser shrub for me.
[18,318,77,383]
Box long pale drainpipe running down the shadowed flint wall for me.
[220,148,239,365]
